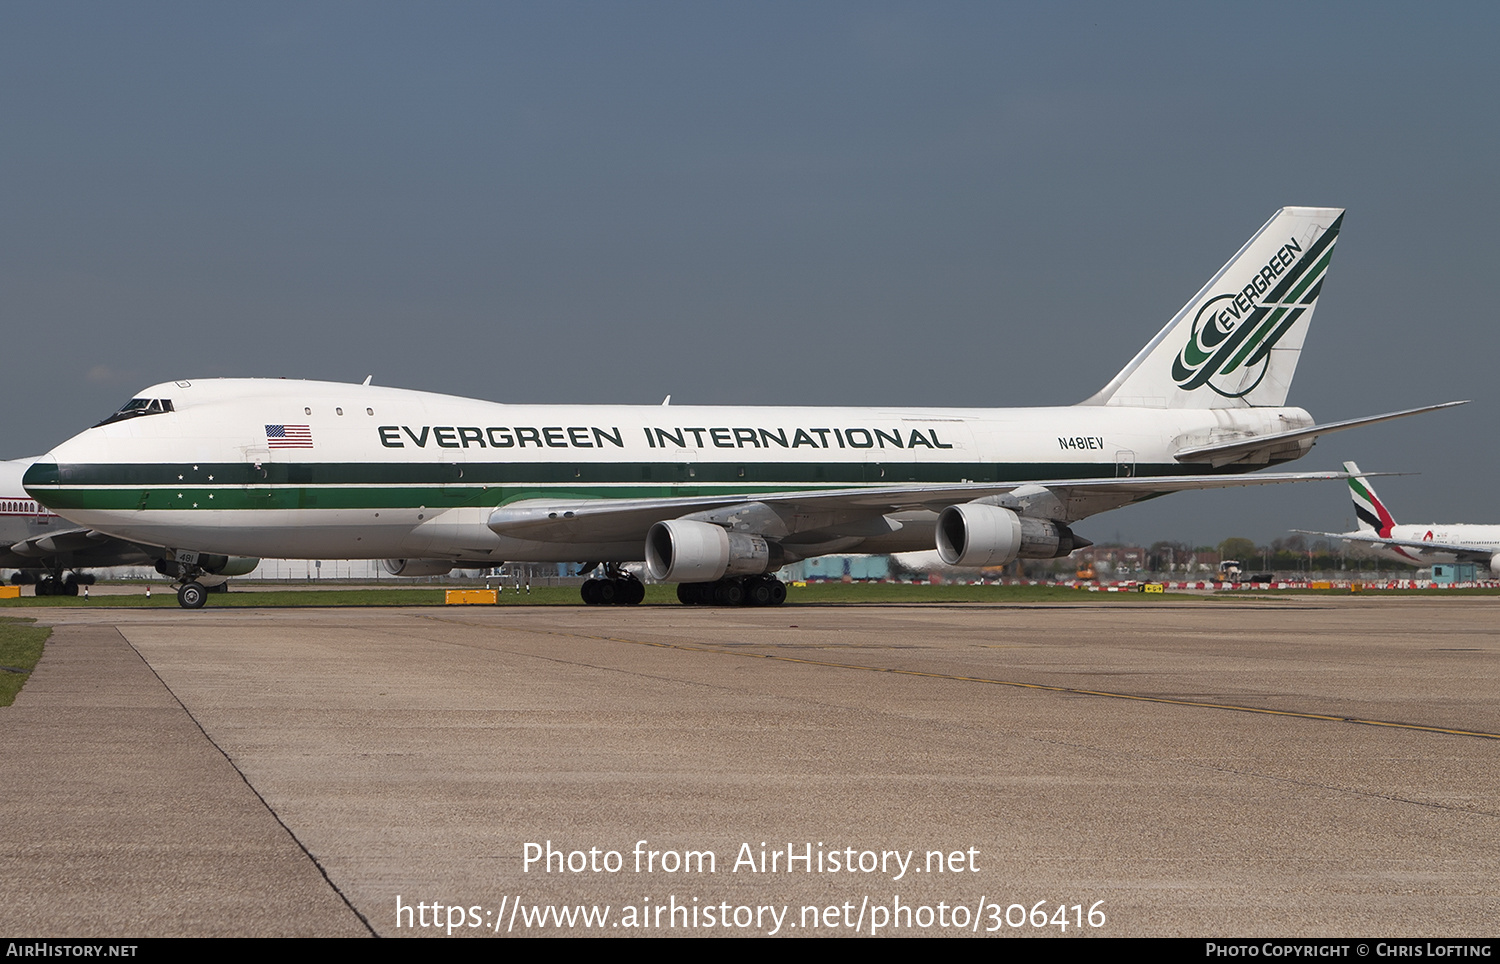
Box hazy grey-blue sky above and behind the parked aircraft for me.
[0,1,1500,541]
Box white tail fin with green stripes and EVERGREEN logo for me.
[1085,207,1344,408]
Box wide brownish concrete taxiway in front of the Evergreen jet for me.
[0,597,1500,937]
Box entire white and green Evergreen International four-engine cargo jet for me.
[17,207,1457,607]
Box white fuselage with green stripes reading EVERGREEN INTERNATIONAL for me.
[27,379,1313,564]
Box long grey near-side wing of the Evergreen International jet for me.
[489,472,1349,543]
